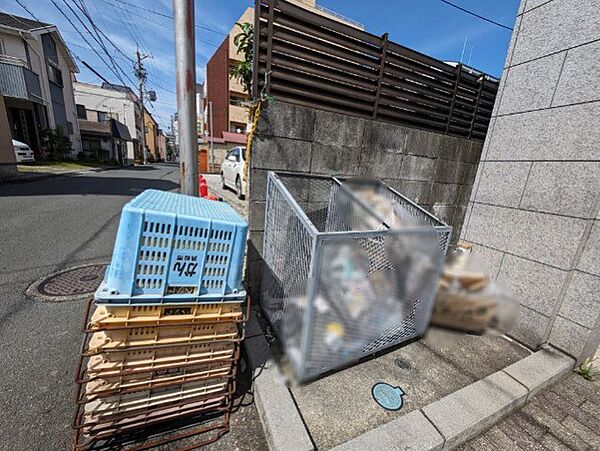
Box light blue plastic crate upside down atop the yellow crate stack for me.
[95,189,248,304]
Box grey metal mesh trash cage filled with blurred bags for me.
[261,172,452,381]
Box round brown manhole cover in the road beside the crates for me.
[27,264,106,301]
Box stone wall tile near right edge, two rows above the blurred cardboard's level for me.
[520,161,600,218]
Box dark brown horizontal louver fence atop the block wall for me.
[253,0,498,140]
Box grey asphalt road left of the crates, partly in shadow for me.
[0,165,264,450]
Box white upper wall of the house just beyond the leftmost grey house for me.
[73,82,139,163]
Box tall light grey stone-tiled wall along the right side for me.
[461,0,600,359]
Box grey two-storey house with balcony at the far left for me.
[0,13,81,156]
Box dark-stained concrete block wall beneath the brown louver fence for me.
[247,101,483,302]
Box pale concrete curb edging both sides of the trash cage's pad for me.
[255,346,575,451]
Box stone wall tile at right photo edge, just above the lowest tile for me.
[560,271,600,329]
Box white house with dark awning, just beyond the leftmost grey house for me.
[73,82,142,165]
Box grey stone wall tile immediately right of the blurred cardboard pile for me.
[498,254,568,316]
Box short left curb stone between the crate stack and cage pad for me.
[254,362,314,451]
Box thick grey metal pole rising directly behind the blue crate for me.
[173,0,198,196]
